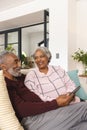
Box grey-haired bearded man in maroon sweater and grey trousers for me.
[0,52,87,130]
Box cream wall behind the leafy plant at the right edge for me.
[68,0,87,73]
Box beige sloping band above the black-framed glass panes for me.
[0,10,44,31]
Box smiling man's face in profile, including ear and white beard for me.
[6,54,21,77]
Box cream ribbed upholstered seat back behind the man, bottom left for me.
[0,70,24,130]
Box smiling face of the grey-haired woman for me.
[34,50,49,69]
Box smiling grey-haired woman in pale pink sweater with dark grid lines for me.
[25,47,80,102]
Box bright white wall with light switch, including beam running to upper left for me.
[0,0,68,70]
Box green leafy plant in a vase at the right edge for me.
[72,48,87,75]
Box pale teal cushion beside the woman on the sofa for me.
[67,70,87,100]
